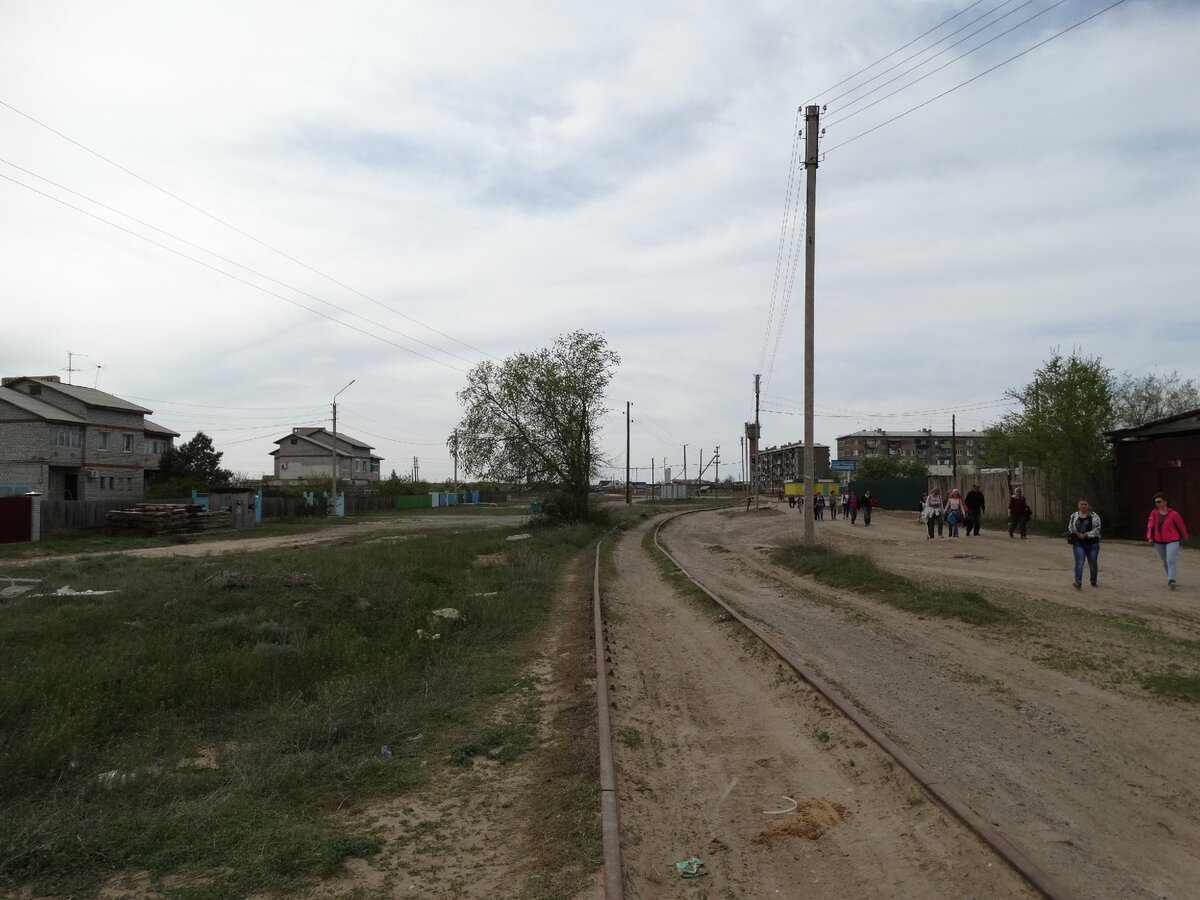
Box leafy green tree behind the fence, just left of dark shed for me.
[982,349,1116,510]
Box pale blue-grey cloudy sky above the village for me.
[0,0,1200,487]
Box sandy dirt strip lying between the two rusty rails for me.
[606,526,1031,900]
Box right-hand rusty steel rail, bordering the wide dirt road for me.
[652,510,1076,900]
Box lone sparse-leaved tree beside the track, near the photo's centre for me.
[446,331,620,521]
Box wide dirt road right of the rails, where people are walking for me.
[666,512,1200,898]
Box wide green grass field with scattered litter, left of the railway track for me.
[0,523,602,900]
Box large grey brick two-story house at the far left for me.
[0,376,179,500]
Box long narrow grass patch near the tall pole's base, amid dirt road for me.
[770,535,1021,625]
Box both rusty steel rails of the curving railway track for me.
[593,510,1075,900]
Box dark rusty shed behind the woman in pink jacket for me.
[1105,409,1200,540]
